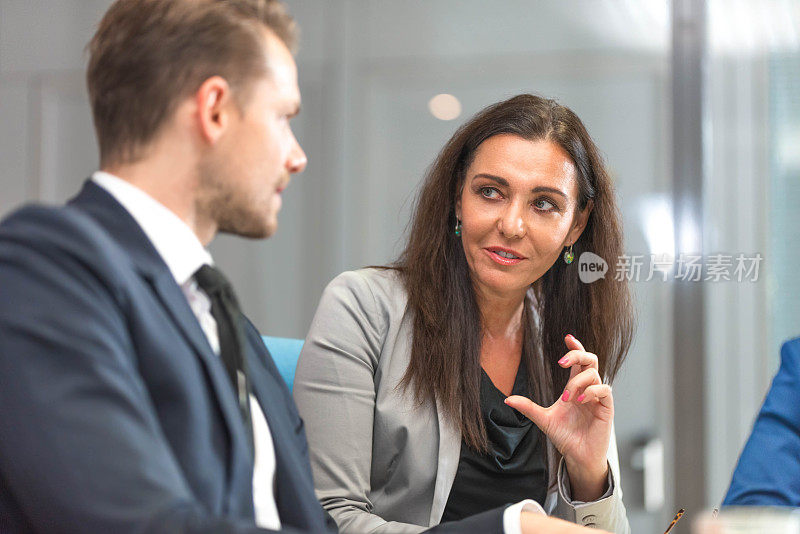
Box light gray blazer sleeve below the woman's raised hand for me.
[546,430,631,534]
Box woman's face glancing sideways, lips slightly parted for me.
[456,134,591,297]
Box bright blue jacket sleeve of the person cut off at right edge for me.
[723,338,800,507]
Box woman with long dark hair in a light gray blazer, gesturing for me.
[294,95,633,532]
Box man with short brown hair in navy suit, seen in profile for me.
[0,0,608,534]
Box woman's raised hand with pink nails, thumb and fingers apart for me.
[505,335,614,501]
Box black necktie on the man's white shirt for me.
[194,265,253,451]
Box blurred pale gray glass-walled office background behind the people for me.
[0,0,800,532]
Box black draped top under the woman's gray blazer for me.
[442,363,548,522]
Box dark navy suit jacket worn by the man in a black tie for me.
[0,182,502,534]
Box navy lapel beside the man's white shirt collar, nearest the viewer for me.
[69,180,252,472]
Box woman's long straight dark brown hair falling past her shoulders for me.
[394,95,633,460]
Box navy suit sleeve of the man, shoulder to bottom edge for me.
[0,208,328,534]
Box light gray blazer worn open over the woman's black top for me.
[294,269,630,533]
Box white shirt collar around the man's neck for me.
[92,171,214,286]
